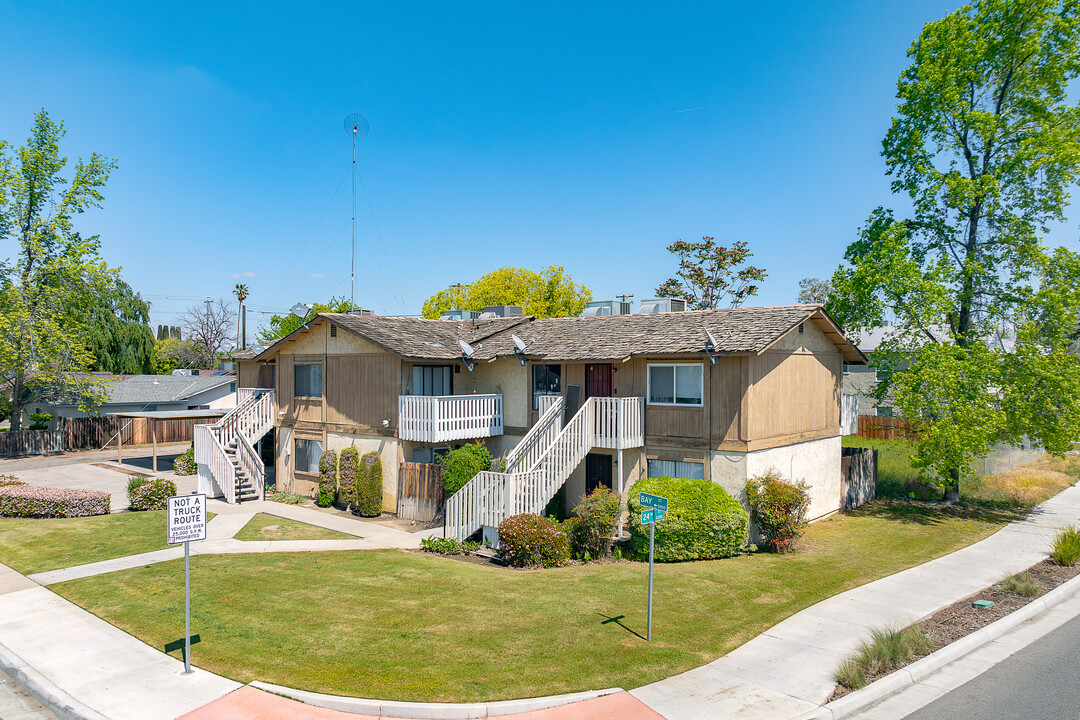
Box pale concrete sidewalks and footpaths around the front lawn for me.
[0,487,1080,720]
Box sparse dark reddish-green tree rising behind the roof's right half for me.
[657,235,766,310]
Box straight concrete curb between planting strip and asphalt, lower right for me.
[794,575,1080,720]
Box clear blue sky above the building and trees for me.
[0,0,1077,331]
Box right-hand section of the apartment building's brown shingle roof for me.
[476,304,865,364]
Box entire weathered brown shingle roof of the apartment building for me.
[248,304,866,364]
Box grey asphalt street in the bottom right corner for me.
[906,617,1080,720]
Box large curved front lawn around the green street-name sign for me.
[52,502,1010,702]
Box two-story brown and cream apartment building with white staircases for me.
[217,305,866,527]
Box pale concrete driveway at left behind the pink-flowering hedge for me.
[0,444,199,513]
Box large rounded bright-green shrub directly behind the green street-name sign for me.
[630,477,748,562]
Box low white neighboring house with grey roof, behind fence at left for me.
[31,375,237,425]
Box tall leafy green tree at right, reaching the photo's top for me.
[829,0,1080,502]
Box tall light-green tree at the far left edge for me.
[0,110,118,430]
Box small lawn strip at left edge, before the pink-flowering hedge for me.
[0,510,180,574]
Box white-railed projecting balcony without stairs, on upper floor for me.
[397,395,502,443]
